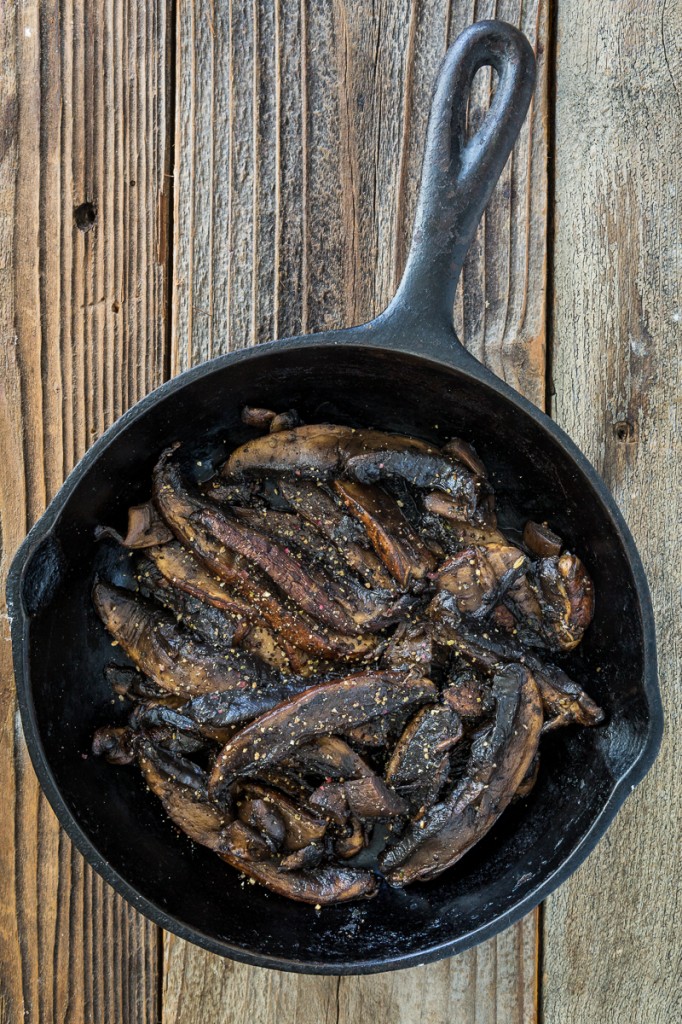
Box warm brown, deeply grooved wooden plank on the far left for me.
[0,0,166,1024]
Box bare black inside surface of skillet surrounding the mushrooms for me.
[19,344,649,971]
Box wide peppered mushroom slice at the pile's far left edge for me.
[92,583,272,696]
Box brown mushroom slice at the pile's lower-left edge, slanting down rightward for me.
[138,742,229,850]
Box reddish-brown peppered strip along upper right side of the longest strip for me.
[193,509,357,635]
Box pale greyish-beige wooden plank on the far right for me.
[542,0,682,1024]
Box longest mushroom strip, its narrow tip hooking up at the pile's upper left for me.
[154,449,377,659]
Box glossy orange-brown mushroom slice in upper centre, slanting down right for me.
[334,480,435,590]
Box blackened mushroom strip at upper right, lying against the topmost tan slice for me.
[345,450,483,521]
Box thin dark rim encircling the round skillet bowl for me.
[7,335,664,975]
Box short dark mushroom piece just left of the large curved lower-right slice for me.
[384,705,462,788]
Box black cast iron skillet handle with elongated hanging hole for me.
[386,22,536,333]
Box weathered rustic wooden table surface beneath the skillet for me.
[0,0,682,1024]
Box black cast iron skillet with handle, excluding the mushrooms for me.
[8,22,663,974]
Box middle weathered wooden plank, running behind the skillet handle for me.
[163,0,548,1024]
